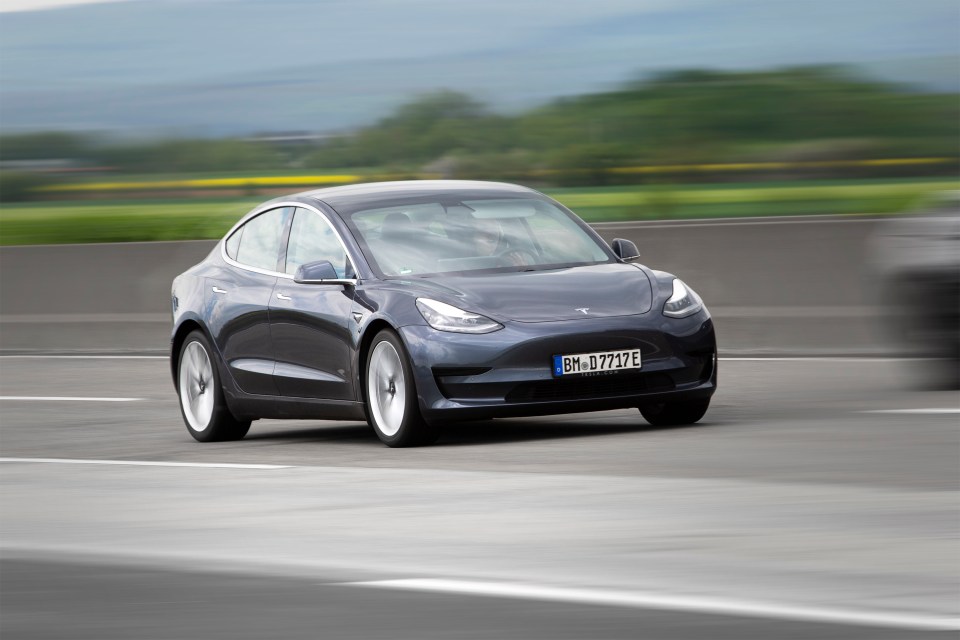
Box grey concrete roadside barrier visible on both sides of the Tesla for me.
[0,217,888,354]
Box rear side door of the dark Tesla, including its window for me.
[212,207,293,396]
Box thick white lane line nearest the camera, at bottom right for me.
[342,578,960,631]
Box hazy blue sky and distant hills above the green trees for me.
[0,0,960,129]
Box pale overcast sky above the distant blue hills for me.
[0,0,960,74]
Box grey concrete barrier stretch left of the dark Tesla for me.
[0,241,216,353]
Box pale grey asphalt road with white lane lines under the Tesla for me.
[0,357,960,638]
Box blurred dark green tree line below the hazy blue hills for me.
[0,67,960,199]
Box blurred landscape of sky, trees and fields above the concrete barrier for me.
[0,0,960,244]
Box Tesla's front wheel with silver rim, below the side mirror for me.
[364,329,438,447]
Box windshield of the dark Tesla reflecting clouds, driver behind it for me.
[350,198,612,276]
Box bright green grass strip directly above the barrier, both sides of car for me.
[0,179,960,245]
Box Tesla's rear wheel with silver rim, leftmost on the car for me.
[177,331,250,442]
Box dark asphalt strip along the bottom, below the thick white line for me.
[0,560,955,640]
